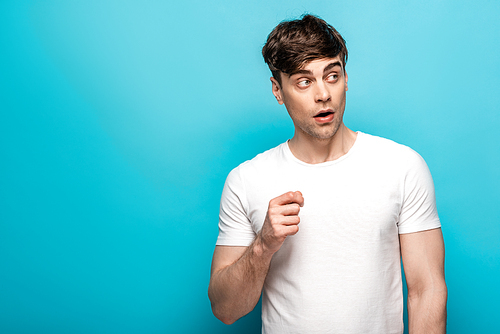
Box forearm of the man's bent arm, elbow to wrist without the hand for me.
[208,237,272,324]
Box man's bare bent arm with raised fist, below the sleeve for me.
[208,191,304,324]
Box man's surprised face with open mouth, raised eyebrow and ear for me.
[271,57,347,139]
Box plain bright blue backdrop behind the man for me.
[0,0,500,333]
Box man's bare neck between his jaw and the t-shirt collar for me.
[288,124,357,164]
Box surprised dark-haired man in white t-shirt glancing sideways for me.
[208,15,447,333]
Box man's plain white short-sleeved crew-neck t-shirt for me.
[217,132,441,334]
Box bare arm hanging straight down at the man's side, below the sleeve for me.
[399,228,448,334]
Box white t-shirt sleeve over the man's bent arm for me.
[217,168,255,246]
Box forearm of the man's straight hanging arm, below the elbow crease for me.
[408,286,448,334]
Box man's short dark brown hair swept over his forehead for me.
[262,14,347,84]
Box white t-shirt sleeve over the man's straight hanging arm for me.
[398,149,441,234]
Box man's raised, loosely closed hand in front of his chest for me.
[257,191,304,254]
